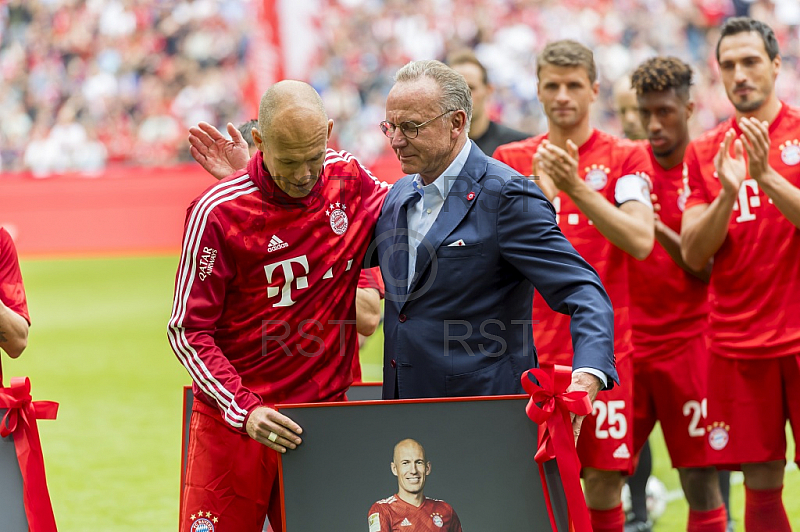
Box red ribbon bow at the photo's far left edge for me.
[0,377,58,532]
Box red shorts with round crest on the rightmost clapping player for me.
[706,355,800,469]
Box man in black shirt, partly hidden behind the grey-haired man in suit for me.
[447,51,528,155]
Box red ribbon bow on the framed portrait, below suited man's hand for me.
[522,366,592,532]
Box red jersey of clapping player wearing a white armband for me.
[494,129,650,366]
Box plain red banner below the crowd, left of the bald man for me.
[0,163,211,256]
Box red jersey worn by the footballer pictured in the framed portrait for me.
[368,495,461,532]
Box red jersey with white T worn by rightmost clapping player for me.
[685,103,800,358]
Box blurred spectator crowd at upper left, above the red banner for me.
[0,0,254,170]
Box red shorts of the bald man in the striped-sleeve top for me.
[180,400,283,532]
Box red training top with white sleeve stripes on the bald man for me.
[168,149,388,431]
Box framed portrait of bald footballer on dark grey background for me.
[278,396,568,532]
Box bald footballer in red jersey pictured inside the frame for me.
[368,439,461,532]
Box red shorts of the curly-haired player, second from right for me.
[633,335,710,467]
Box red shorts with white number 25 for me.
[578,357,634,475]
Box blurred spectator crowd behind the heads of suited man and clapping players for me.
[309,0,800,168]
